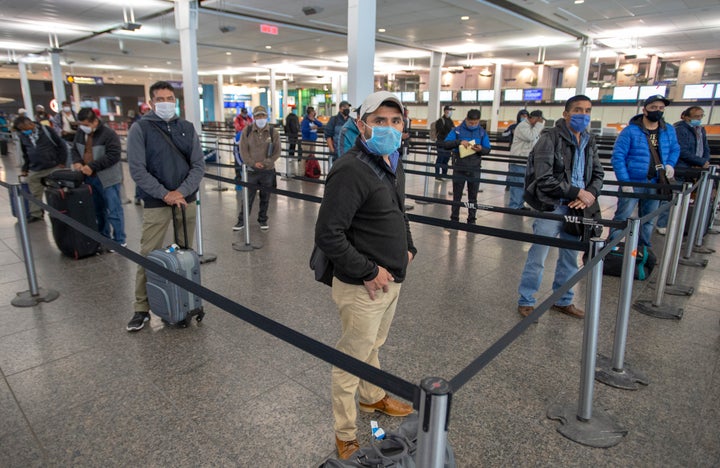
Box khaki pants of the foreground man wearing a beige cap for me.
[332,278,400,440]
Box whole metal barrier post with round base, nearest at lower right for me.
[547,238,628,448]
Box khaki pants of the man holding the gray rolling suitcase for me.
[133,202,197,312]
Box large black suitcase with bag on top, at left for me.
[43,170,100,260]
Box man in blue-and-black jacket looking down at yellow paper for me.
[444,109,490,224]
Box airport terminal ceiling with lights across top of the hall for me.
[0,0,720,87]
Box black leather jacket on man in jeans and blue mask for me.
[524,120,605,211]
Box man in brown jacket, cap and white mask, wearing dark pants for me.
[233,106,282,231]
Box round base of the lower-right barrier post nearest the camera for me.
[547,404,628,448]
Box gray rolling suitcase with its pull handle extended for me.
[147,207,205,328]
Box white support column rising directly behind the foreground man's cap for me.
[347,0,377,106]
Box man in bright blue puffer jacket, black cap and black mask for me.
[609,94,680,247]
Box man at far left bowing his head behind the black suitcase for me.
[13,115,67,223]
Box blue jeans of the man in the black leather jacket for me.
[518,205,579,306]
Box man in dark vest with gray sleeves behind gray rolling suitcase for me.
[127,81,205,332]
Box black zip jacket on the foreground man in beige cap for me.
[315,139,417,284]
